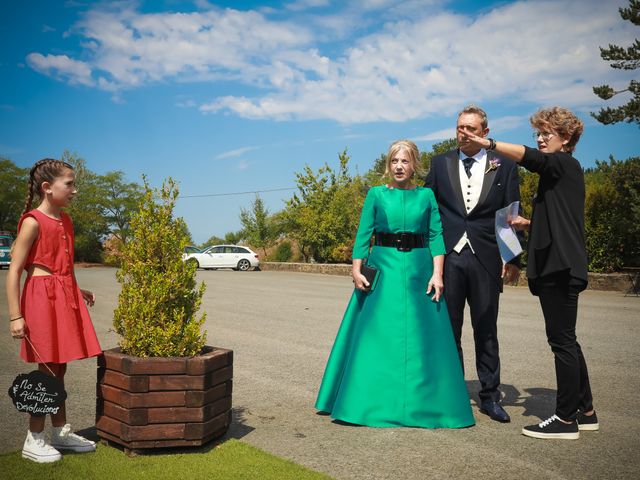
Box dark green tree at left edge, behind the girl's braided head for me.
[0,158,29,232]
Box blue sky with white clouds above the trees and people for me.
[0,0,640,243]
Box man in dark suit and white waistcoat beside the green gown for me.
[425,105,520,422]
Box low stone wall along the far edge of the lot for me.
[260,262,632,293]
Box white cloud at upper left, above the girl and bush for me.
[35,3,312,91]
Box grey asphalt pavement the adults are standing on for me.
[0,268,640,479]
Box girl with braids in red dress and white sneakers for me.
[7,158,102,463]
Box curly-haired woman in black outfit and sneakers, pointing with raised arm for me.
[458,107,599,440]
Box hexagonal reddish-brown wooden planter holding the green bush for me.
[96,347,233,453]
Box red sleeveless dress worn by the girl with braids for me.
[18,209,102,363]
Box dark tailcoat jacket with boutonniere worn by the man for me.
[425,150,520,288]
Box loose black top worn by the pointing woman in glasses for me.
[520,146,587,286]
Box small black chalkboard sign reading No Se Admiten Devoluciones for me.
[9,370,67,417]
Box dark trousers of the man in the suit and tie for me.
[444,247,500,402]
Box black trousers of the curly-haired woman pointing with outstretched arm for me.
[536,276,593,420]
